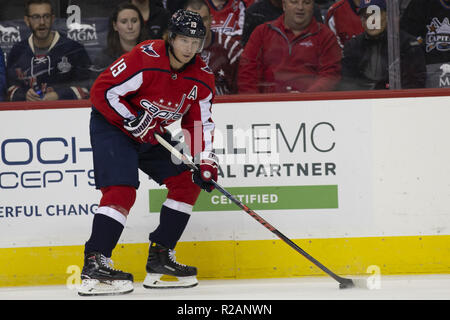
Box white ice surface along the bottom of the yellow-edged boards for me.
[0,274,450,302]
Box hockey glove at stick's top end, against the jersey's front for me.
[123,111,164,145]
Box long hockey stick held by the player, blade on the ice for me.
[155,133,367,289]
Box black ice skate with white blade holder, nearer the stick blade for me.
[143,243,198,289]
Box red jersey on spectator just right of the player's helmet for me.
[206,0,255,36]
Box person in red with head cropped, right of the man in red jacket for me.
[325,0,364,48]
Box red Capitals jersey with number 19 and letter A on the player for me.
[91,40,215,155]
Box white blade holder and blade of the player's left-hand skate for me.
[78,279,134,296]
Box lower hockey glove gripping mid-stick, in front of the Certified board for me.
[192,151,219,192]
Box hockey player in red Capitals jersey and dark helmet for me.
[79,9,218,295]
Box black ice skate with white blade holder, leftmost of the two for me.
[78,252,134,296]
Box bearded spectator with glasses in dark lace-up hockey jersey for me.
[7,0,91,101]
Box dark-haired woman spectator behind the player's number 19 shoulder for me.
[94,2,147,76]
